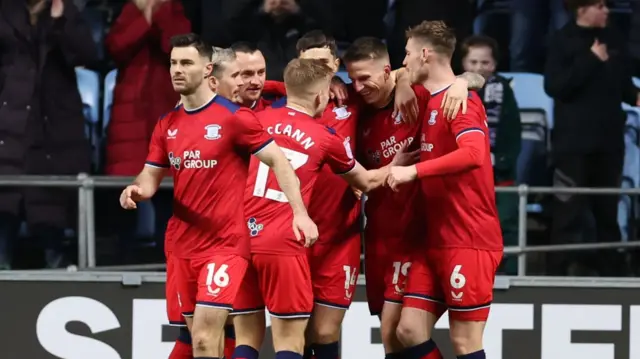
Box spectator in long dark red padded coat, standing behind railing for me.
[105,0,191,260]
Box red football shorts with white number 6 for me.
[403,248,503,321]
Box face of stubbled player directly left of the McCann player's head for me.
[236,51,267,103]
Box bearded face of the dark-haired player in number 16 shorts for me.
[169,46,211,95]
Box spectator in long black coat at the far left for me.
[0,0,97,269]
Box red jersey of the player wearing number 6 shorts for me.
[420,90,503,250]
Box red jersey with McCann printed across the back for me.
[245,107,355,255]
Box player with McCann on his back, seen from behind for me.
[234,59,412,359]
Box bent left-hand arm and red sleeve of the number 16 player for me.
[120,119,171,209]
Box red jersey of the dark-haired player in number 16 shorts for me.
[146,95,272,258]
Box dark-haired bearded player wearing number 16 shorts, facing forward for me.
[120,34,318,359]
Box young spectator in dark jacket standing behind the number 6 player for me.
[461,36,522,275]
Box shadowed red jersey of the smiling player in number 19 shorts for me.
[358,85,430,240]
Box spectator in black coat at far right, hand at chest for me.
[544,0,640,275]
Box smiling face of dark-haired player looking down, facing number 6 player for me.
[347,60,393,104]
